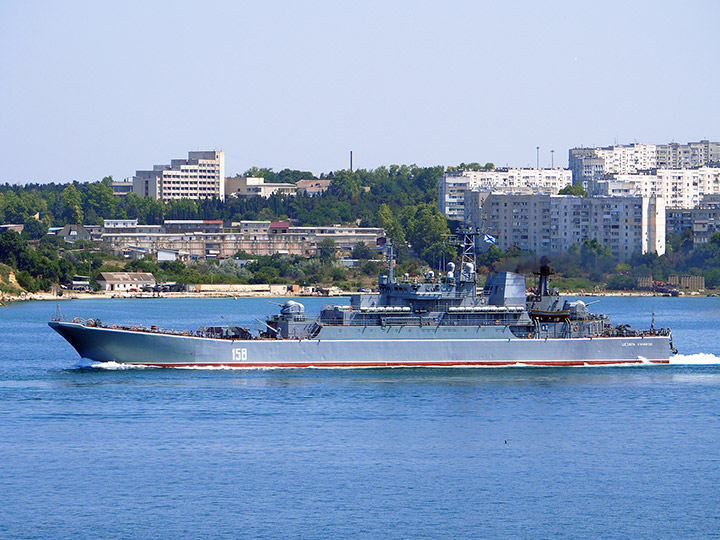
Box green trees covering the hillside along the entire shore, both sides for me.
[0,163,720,290]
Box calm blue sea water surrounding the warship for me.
[0,298,720,539]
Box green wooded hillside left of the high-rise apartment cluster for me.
[0,165,452,291]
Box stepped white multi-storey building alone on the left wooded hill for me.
[133,151,225,201]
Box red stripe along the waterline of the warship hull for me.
[126,360,670,368]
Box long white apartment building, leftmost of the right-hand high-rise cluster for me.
[438,168,572,219]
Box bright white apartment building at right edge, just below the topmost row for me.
[598,167,720,208]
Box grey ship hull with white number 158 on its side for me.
[49,321,670,368]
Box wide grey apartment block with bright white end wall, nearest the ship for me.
[466,190,665,260]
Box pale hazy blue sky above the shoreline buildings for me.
[0,0,720,183]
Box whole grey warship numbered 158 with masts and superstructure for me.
[48,230,677,368]
